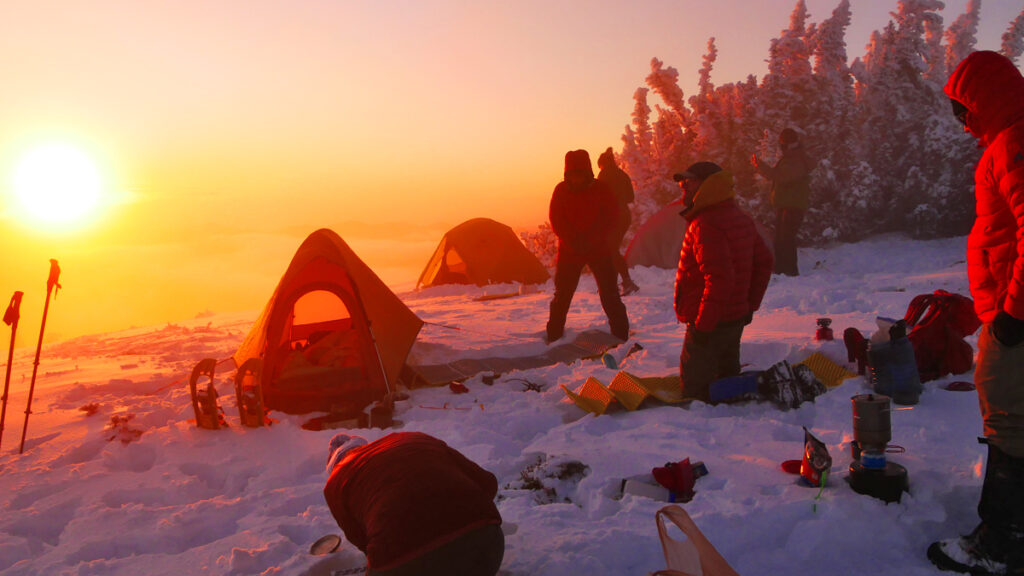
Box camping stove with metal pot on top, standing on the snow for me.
[848,394,909,502]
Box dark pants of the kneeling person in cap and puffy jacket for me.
[679,320,744,402]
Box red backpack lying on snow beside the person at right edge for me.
[903,290,981,382]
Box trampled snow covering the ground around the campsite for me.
[0,237,984,576]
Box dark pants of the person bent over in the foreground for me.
[367,524,505,576]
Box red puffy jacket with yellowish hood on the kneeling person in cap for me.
[675,171,774,332]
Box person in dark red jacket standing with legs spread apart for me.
[547,150,630,342]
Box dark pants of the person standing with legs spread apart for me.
[548,253,630,342]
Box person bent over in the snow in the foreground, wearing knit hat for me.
[324,433,505,576]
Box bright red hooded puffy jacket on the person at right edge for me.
[945,51,1024,322]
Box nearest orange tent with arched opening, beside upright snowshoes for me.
[234,229,423,415]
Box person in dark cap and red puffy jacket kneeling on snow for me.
[673,162,774,402]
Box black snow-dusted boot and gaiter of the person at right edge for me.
[928,438,1024,575]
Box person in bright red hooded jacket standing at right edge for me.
[928,51,1024,574]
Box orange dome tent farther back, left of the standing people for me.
[417,218,551,287]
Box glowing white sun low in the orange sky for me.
[13,143,103,224]
